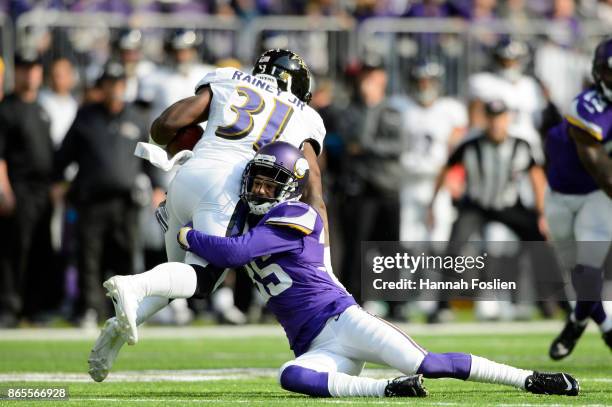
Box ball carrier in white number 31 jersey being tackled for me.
[89,49,329,381]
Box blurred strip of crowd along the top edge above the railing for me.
[0,0,612,24]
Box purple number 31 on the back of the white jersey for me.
[215,86,293,151]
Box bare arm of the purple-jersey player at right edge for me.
[569,126,612,198]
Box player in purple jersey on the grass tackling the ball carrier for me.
[178,142,579,397]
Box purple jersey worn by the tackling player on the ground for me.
[187,202,356,356]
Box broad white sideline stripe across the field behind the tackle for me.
[0,321,596,341]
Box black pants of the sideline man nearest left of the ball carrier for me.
[77,198,138,318]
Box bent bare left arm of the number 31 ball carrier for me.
[151,86,212,145]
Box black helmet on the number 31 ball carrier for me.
[253,49,312,103]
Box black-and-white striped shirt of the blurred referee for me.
[447,132,536,210]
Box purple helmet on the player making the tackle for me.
[240,141,310,215]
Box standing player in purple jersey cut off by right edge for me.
[545,37,612,360]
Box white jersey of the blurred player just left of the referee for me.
[401,97,468,177]
